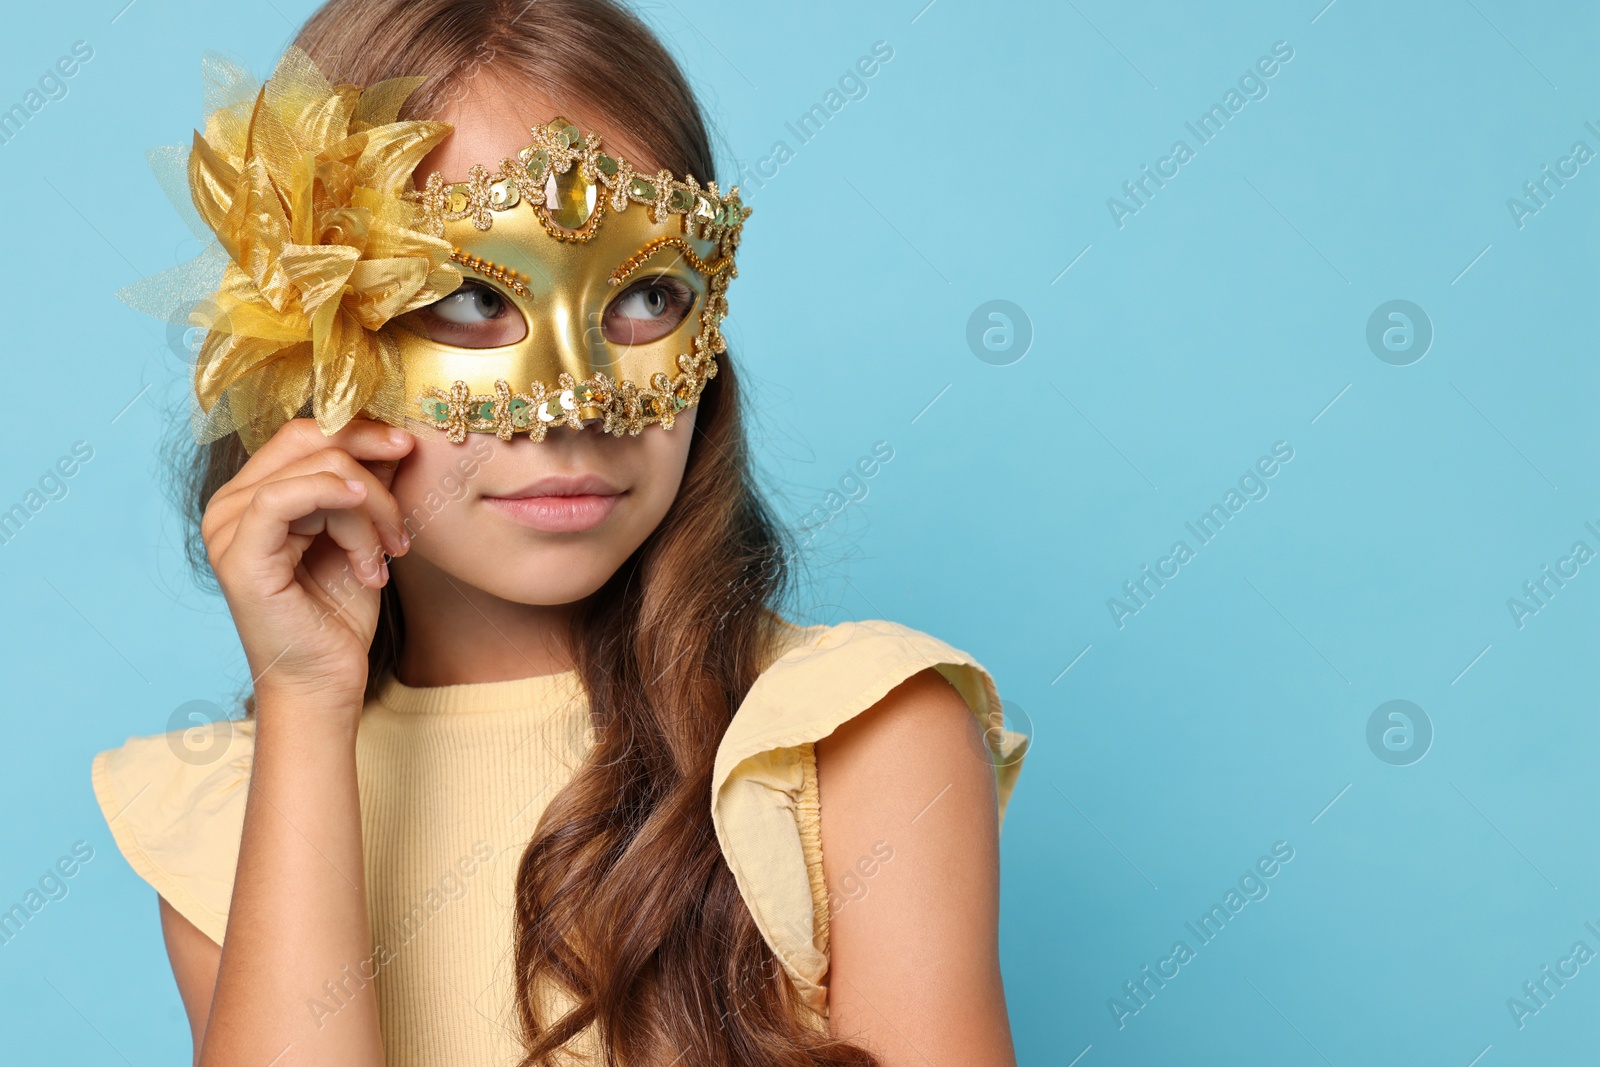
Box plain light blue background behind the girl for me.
[0,0,1600,1067]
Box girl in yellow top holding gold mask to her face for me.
[93,0,1026,1067]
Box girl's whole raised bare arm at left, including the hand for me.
[162,419,411,1067]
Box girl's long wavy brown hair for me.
[171,0,877,1067]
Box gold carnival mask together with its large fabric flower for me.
[118,45,750,453]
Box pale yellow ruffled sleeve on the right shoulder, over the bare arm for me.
[712,619,1027,1019]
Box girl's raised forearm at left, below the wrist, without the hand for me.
[198,704,384,1067]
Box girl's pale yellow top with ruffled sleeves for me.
[91,619,1027,1067]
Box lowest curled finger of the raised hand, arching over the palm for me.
[224,470,382,587]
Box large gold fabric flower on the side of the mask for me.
[189,46,462,453]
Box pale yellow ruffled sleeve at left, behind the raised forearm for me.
[90,720,256,944]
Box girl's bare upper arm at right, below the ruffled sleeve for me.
[816,667,1016,1067]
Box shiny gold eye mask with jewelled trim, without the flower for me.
[395,117,750,442]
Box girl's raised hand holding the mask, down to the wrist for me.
[200,419,416,728]
